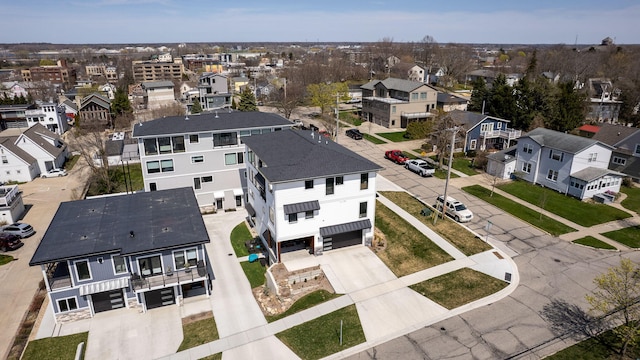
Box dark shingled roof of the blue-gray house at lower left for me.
[29,187,209,265]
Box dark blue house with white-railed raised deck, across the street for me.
[434,110,522,153]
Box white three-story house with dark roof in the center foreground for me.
[243,130,382,262]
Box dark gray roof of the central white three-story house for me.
[242,130,382,182]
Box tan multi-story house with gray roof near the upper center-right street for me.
[361,78,438,129]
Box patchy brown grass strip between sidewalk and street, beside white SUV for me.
[380,191,491,256]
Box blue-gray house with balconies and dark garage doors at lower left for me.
[29,188,211,322]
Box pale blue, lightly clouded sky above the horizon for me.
[0,0,640,44]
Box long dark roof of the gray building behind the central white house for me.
[133,110,293,137]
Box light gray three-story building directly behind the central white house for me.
[132,110,293,211]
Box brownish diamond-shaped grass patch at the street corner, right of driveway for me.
[410,268,509,310]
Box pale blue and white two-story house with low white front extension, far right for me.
[516,128,622,200]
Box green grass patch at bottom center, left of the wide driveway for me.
[276,305,366,359]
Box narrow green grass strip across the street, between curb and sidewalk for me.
[462,185,576,236]
